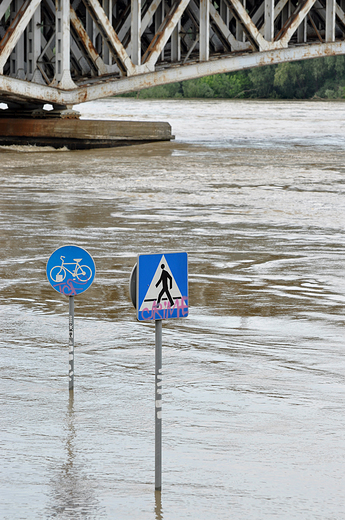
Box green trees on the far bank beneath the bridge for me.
[121,56,345,99]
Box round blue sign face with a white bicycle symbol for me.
[47,246,96,296]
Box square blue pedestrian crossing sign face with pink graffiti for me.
[136,253,188,321]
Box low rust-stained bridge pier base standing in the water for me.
[0,102,174,150]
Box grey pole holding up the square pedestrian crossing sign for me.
[155,320,162,491]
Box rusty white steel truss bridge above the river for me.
[0,0,345,111]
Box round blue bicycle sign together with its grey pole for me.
[46,246,96,390]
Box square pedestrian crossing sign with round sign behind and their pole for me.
[129,253,188,491]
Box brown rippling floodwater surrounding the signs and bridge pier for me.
[0,98,345,520]
